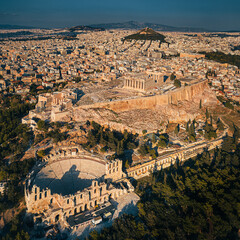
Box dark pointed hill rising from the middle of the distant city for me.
[124,28,166,42]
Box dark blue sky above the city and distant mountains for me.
[0,0,240,31]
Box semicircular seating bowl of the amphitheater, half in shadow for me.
[34,157,105,195]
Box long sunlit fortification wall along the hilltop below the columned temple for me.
[73,81,208,114]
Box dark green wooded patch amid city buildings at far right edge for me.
[203,52,240,68]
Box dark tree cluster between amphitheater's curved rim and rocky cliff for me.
[85,121,138,156]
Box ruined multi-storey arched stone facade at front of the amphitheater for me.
[25,181,128,224]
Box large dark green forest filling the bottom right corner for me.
[89,133,240,240]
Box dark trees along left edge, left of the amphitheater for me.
[0,95,34,215]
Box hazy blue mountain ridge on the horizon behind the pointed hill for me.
[90,21,209,32]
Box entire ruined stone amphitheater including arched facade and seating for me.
[25,147,134,225]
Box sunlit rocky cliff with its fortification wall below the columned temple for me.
[73,81,217,133]
